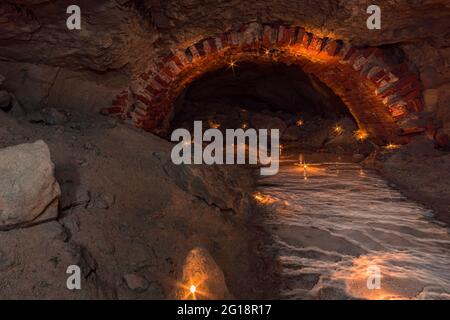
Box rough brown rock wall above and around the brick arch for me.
[0,0,450,144]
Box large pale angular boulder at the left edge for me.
[0,140,61,229]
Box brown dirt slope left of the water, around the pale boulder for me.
[0,110,275,299]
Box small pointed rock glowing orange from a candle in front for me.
[177,248,232,300]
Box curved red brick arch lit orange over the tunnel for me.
[102,23,424,143]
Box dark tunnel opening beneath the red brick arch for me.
[169,61,356,147]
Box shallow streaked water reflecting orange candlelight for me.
[258,163,450,299]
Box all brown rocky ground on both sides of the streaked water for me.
[0,97,450,299]
